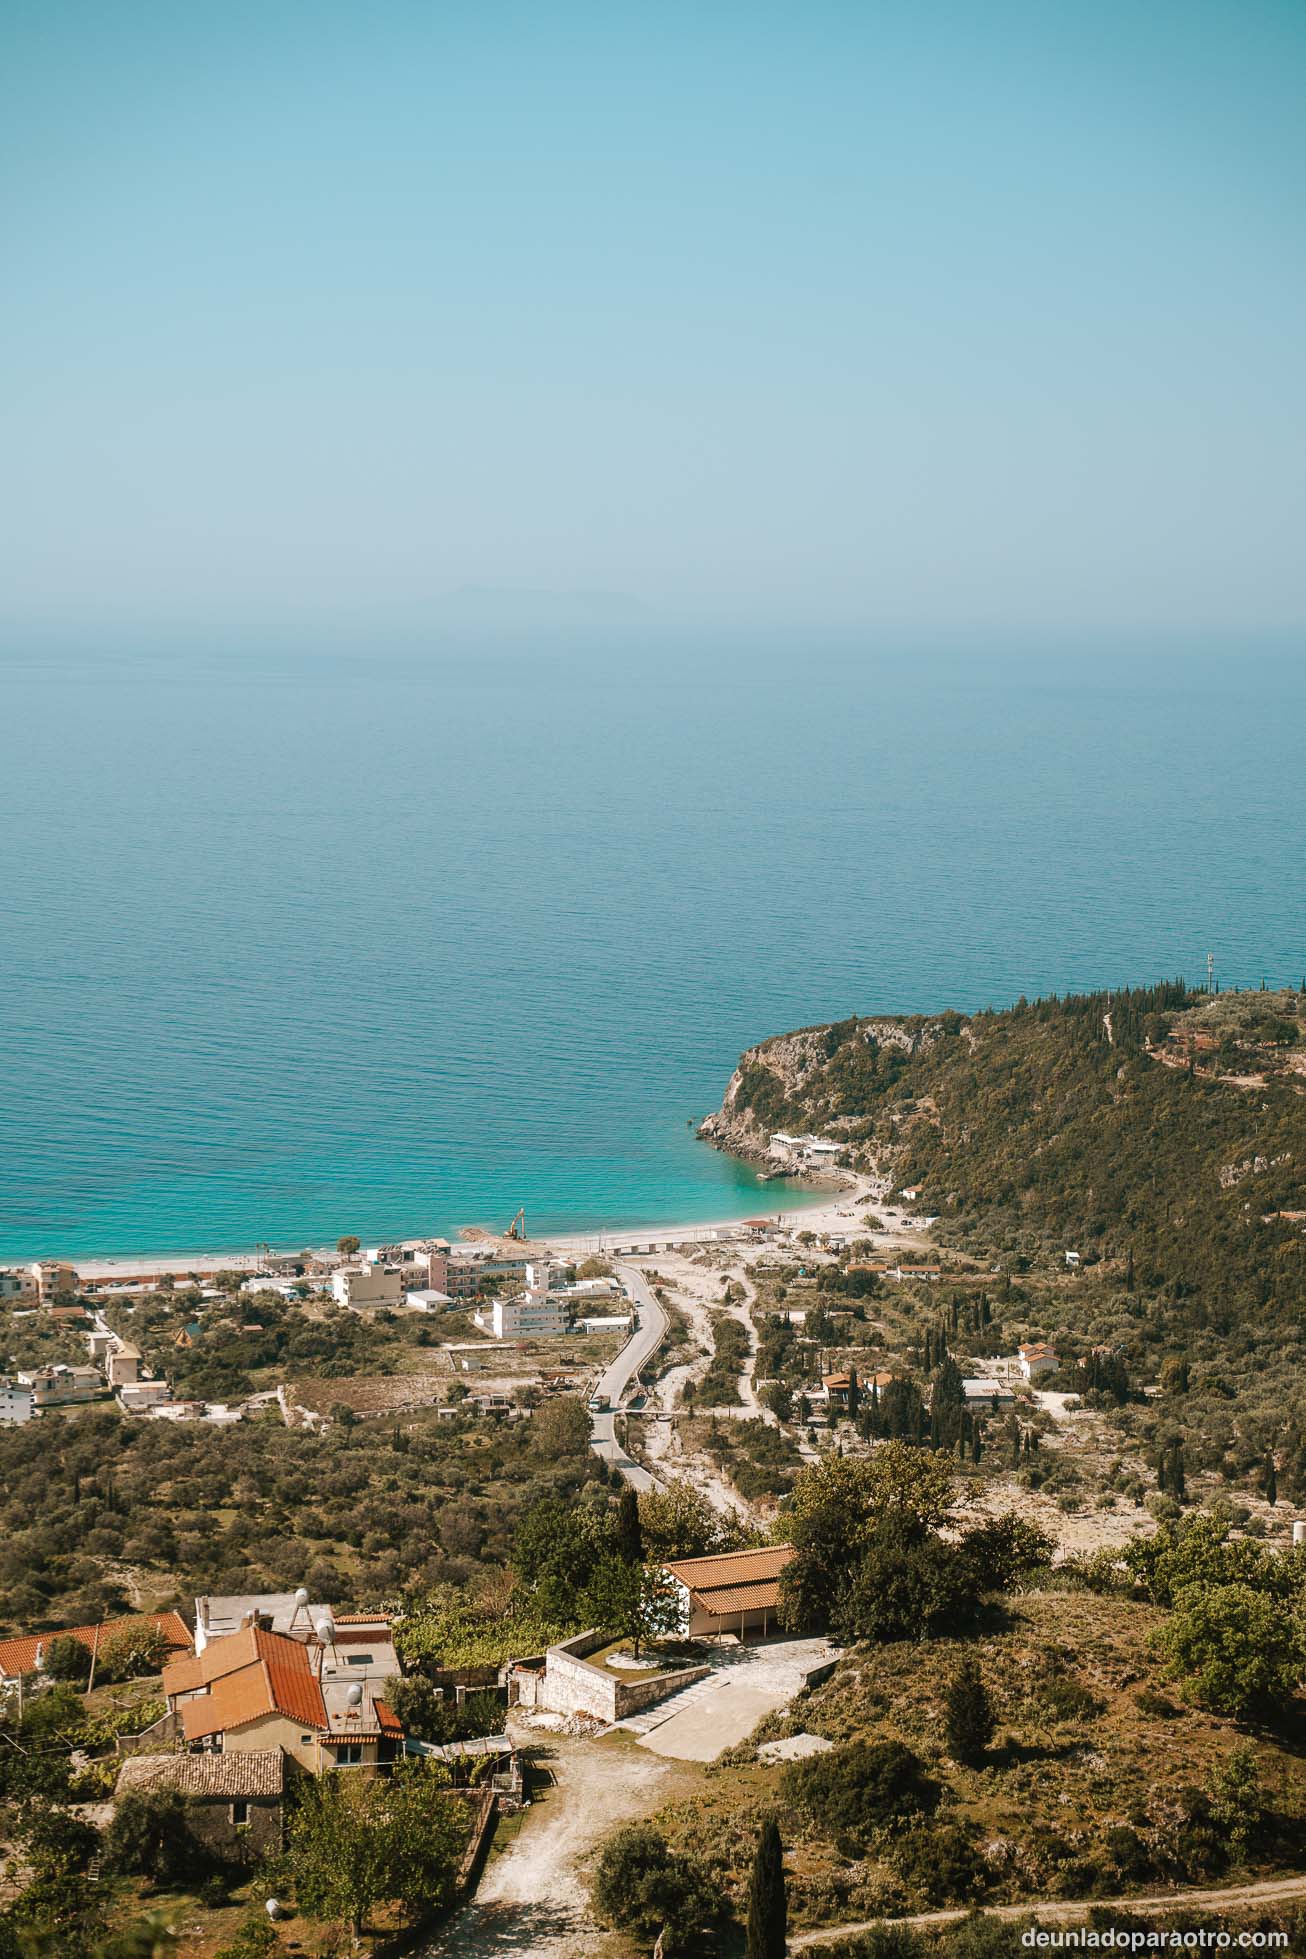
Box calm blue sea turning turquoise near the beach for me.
[0,645,1306,1258]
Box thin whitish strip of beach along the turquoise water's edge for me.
[49,1171,883,1283]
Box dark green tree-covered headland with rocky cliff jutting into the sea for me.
[705,983,1306,1326]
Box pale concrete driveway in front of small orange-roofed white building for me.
[619,1640,840,1761]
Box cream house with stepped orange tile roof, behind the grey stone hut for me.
[163,1620,403,1775]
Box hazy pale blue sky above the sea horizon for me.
[0,0,1306,639]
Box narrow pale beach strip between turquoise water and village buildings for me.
[23,1171,875,1283]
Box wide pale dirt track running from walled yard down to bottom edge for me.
[419,1734,697,1959]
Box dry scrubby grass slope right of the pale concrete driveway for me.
[662,1593,1306,1926]
